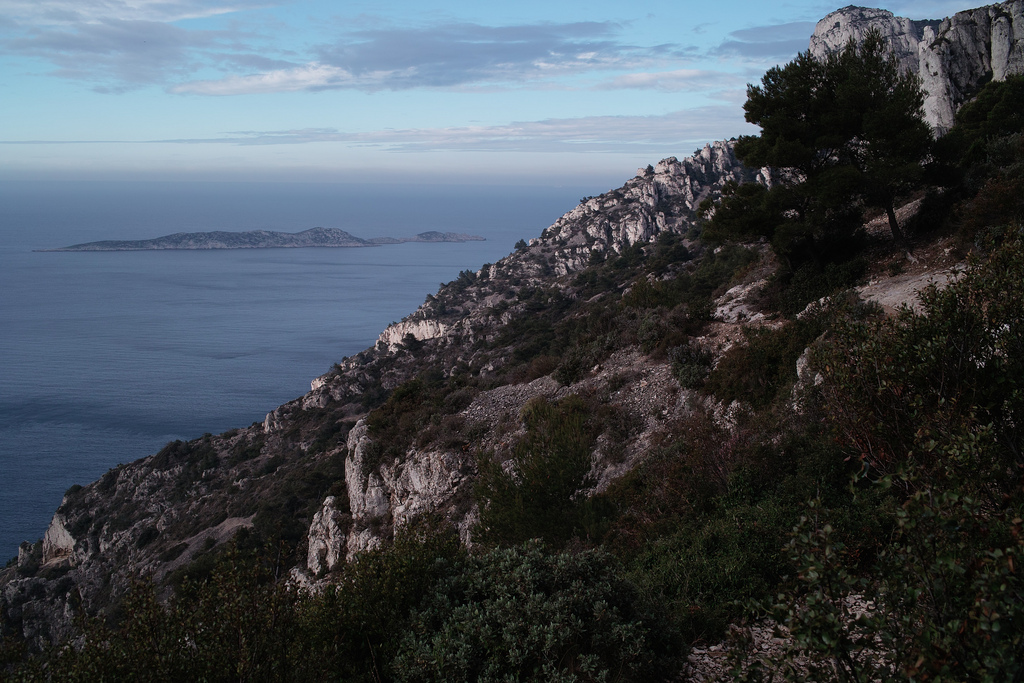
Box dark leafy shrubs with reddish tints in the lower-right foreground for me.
[775,230,1024,681]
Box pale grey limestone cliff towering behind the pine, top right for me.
[810,0,1024,133]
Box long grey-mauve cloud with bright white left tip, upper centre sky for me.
[173,22,690,95]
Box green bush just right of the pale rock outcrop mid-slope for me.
[474,395,598,546]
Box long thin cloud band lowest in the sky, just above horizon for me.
[0,105,753,154]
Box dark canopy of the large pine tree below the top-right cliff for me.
[706,28,932,254]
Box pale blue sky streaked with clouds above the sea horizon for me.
[0,0,980,186]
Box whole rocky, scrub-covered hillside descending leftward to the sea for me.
[0,1,1024,680]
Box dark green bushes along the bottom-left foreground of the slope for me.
[8,519,679,683]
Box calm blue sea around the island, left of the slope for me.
[0,180,606,562]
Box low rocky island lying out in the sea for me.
[36,227,484,252]
